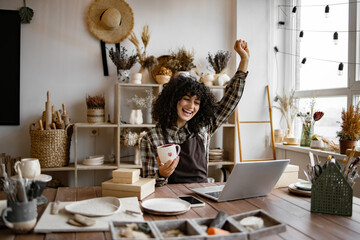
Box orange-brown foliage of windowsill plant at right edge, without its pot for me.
[337,104,360,141]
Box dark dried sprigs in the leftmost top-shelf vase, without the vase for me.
[109,46,138,70]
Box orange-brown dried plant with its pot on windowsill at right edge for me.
[337,104,360,154]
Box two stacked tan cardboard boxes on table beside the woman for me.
[101,168,155,200]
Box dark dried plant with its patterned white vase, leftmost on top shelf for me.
[109,46,138,83]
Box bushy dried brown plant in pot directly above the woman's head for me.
[168,48,195,76]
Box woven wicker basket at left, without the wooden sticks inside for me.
[30,124,73,168]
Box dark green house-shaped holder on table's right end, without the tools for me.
[311,163,353,216]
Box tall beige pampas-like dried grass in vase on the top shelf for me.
[129,25,157,83]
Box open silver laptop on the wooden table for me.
[191,159,290,202]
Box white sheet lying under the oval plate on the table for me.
[34,197,144,233]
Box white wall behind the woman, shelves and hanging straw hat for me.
[0,0,273,185]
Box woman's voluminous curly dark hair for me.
[152,75,216,133]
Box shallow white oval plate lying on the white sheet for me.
[65,197,120,217]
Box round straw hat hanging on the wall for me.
[86,0,134,43]
